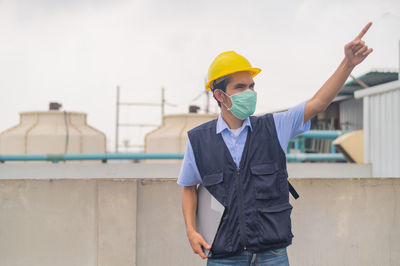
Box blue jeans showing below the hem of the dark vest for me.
[207,248,289,266]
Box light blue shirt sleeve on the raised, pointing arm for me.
[273,102,311,153]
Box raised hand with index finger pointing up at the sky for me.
[344,22,372,67]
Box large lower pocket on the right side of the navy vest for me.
[258,203,293,244]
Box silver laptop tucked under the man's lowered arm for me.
[196,185,225,256]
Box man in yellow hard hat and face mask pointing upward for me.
[178,23,372,265]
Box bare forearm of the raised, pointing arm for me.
[311,58,354,112]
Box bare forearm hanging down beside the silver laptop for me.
[182,186,197,234]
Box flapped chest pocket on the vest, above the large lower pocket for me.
[250,163,280,199]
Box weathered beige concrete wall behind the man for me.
[0,164,400,266]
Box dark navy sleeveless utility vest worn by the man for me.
[188,114,293,258]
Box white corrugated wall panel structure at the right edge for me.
[355,81,400,177]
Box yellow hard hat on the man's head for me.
[206,51,261,91]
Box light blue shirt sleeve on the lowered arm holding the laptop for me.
[177,140,202,186]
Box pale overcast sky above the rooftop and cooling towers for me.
[0,0,400,151]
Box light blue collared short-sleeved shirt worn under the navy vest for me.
[177,102,311,186]
